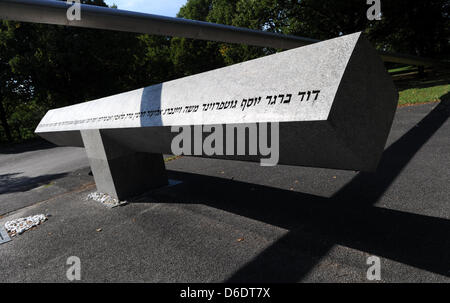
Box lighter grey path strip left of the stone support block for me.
[0,141,93,215]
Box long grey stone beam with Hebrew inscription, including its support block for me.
[36,33,398,198]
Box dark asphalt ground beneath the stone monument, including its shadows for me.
[0,96,450,282]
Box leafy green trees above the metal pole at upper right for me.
[181,0,450,59]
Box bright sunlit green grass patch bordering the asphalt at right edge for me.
[398,84,450,105]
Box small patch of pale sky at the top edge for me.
[105,0,187,17]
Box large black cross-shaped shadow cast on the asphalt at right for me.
[130,94,450,282]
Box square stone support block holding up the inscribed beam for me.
[81,130,168,200]
